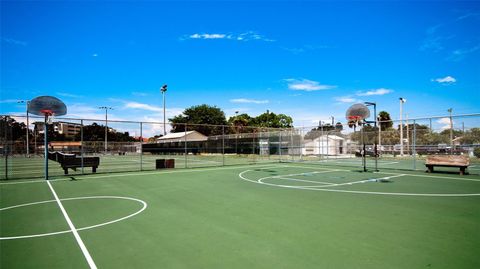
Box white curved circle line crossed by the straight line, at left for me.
[0,196,147,240]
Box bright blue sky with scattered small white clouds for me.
[0,1,480,133]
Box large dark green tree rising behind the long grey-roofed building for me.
[169,104,227,136]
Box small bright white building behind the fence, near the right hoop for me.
[302,135,346,155]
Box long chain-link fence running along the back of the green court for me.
[0,114,480,179]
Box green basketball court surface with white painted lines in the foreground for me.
[0,162,480,268]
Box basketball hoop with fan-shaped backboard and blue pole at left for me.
[28,96,67,180]
